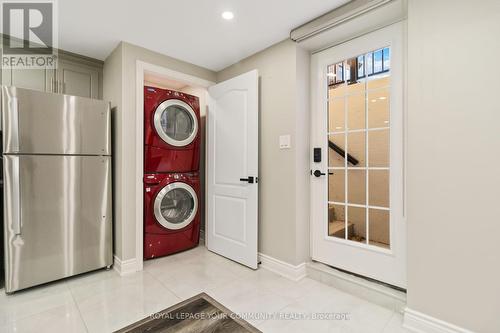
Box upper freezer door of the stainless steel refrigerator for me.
[2,86,111,155]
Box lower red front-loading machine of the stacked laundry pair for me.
[144,172,200,260]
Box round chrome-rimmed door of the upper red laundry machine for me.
[153,99,198,147]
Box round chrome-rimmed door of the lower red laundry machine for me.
[154,182,198,230]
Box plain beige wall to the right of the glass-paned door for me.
[407,0,500,333]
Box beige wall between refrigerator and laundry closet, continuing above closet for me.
[104,42,216,260]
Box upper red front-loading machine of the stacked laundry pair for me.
[144,86,201,174]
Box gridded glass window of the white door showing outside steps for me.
[327,47,390,248]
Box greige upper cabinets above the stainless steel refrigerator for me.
[2,51,103,99]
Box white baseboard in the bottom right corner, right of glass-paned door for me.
[403,308,474,333]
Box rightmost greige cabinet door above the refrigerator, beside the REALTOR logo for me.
[57,60,99,99]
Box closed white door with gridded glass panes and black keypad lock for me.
[311,24,406,288]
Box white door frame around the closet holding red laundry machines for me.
[134,60,216,273]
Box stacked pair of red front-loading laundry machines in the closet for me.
[144,86,201,259]
